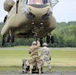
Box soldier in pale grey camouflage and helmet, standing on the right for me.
[40,43,51,70]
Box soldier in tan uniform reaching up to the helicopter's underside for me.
[29,41,41,74]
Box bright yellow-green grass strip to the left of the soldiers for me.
[0,50,29,66]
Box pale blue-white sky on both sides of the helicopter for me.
[0,0,76,22]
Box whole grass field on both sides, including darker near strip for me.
[0,46,76,73]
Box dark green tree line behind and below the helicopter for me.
[0,21,76,47]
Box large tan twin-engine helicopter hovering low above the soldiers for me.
[1,0,58,46]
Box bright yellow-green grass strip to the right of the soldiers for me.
[51,50,76,66]
